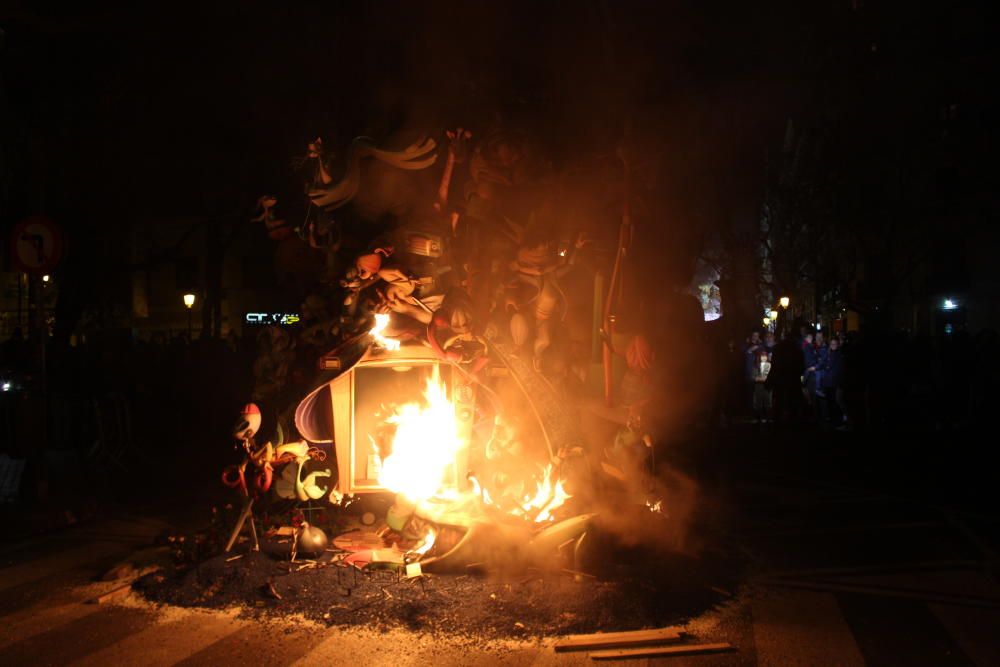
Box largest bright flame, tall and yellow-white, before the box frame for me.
[378,366,465,504]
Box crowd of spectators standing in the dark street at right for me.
[730,327,1000,431]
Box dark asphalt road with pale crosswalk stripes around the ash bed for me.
[0,430,1000,666]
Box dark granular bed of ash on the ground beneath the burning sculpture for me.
[135,528,742,638]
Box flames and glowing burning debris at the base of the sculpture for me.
[364,367,592,572]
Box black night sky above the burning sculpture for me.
[0,0,996,326]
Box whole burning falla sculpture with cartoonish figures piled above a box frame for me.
[222,128,656,568]
